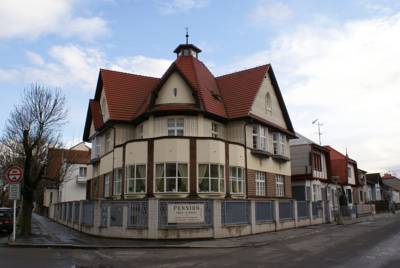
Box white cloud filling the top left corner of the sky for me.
[0,0,107,41]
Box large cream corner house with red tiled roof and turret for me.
[83,40,295,202]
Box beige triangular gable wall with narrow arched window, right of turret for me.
[250,72,288,129]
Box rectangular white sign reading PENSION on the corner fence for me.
[168,203,204,223]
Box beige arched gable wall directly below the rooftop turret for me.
[156,73,195,104]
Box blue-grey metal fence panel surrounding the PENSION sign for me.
[158,200,213,229]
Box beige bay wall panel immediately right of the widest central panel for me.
[197,139,225,165]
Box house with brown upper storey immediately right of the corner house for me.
[290,133,336,204]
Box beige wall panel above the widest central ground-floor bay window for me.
[154,138,189,163]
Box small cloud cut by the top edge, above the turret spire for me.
[156,0,209,15]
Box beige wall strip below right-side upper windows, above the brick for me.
[247,150,291,176]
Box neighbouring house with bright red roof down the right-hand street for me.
[324,146,359,207]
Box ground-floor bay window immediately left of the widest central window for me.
[126,165,146,194]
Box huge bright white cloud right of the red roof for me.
[220,14,400,171]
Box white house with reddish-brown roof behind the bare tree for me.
[44,143,91,206]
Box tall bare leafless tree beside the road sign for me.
[2,84,67,236]
